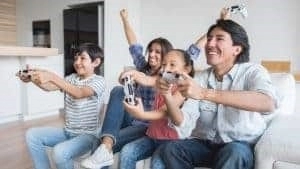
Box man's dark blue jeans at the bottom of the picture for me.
[161,139,254,169]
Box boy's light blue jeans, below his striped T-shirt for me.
[26,127,99,169]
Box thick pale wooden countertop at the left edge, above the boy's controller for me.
[0,46,58,56]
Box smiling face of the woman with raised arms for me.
[148,43,162,71]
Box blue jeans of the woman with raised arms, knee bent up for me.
[101,86,147,152]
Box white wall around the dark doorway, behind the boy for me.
[16,0,140,86]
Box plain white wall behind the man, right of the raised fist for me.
[141,0,300,71]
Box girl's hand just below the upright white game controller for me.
[123,98,145,119]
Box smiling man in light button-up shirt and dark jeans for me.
[160,20,278,169]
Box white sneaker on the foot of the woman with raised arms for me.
[81,144,114,169]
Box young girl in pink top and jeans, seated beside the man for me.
[120,49,199,169]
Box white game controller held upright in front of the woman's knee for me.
[123,76,137,105]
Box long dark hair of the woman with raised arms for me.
[141,37,173,72]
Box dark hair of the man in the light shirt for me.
[207,19,250,63]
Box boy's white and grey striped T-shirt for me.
[65,73,109,135]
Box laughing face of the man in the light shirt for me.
[205,27,241,67]
